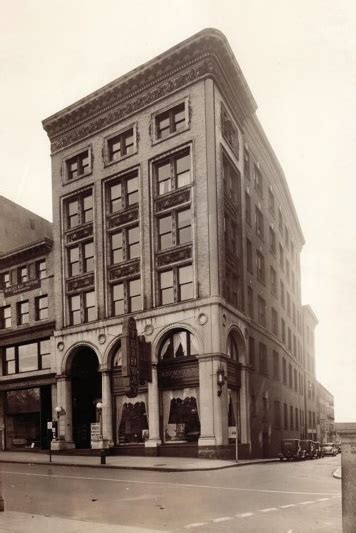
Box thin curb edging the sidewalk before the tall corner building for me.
[0,459,279,472]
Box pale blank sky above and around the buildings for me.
[0,0,356,422]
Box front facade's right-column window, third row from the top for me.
[158,208,192,250]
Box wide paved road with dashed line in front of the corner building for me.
[2,456,341,533]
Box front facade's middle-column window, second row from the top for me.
[108,172,139,213]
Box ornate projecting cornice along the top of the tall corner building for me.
[43,29,257,153]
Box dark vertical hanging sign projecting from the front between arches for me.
[121,317,139,398]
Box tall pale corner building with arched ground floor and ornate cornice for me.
[39,29,328,457]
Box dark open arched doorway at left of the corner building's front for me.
[71,346,101,448]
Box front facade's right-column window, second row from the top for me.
[154,150,191,195]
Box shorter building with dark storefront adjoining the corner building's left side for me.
[0,197,56,448]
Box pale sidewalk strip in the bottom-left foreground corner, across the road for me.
[0,511,167,533]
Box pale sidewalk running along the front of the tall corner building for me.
[0,451,279,472]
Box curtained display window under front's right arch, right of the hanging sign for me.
[162,388,200,443]
